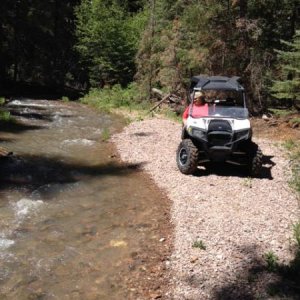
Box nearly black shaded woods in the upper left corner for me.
[0,0,80,86]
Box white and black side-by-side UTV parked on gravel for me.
[176,76,263,176]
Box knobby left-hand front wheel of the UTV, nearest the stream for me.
[176,139,199,175]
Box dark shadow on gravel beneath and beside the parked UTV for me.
[195,155,276,180]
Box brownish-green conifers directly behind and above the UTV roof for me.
[136,0,297,110]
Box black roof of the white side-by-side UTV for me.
[191,75,245,91]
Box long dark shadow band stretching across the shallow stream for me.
[0,155,142,197]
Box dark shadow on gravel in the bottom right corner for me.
[213,246,300,300]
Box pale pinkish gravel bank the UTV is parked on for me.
[112,118,299,299]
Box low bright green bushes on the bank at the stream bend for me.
[81,84,149,111]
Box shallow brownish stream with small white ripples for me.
[0,99,169,299]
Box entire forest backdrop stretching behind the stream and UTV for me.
[0,0,300,113]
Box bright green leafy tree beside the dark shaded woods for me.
[76,0,144,87]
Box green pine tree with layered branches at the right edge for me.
[271,31,300,110]
